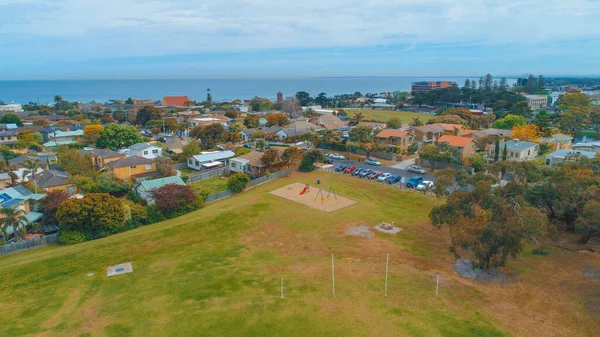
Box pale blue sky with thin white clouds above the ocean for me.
[0,0,600,80]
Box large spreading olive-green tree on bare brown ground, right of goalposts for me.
[429,182,547,270]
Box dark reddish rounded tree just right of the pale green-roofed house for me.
[149,184,201,214]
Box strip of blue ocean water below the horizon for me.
[0,76,515,104]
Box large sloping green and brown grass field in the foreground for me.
[0,172,600,336]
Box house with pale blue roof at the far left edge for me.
[0,185,46,241]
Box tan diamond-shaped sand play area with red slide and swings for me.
[269,183,356,212]
